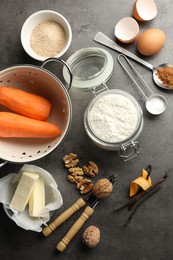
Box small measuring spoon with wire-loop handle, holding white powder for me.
[118,54,167,115]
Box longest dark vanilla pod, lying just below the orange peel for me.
[113,173,168,212]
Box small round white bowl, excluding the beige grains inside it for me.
[21,10,72,61]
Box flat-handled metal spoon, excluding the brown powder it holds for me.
[94,32,173,90]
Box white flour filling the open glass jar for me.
[88,94,138,143]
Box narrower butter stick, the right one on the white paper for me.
[29,177,45,217]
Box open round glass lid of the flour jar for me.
[63,47,114,89]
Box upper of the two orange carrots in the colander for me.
[0,86,51,120]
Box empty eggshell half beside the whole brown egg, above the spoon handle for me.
[115,17,139,43]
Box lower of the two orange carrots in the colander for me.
[0,112,61,138]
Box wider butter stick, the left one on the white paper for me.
[10,171,39,212]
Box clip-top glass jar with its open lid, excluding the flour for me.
[63,47,143,160]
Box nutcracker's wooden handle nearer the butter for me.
[42,198,86,237]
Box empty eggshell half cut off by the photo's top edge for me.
[133,0,157,22]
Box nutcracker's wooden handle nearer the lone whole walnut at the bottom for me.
[56,200,98,252]
